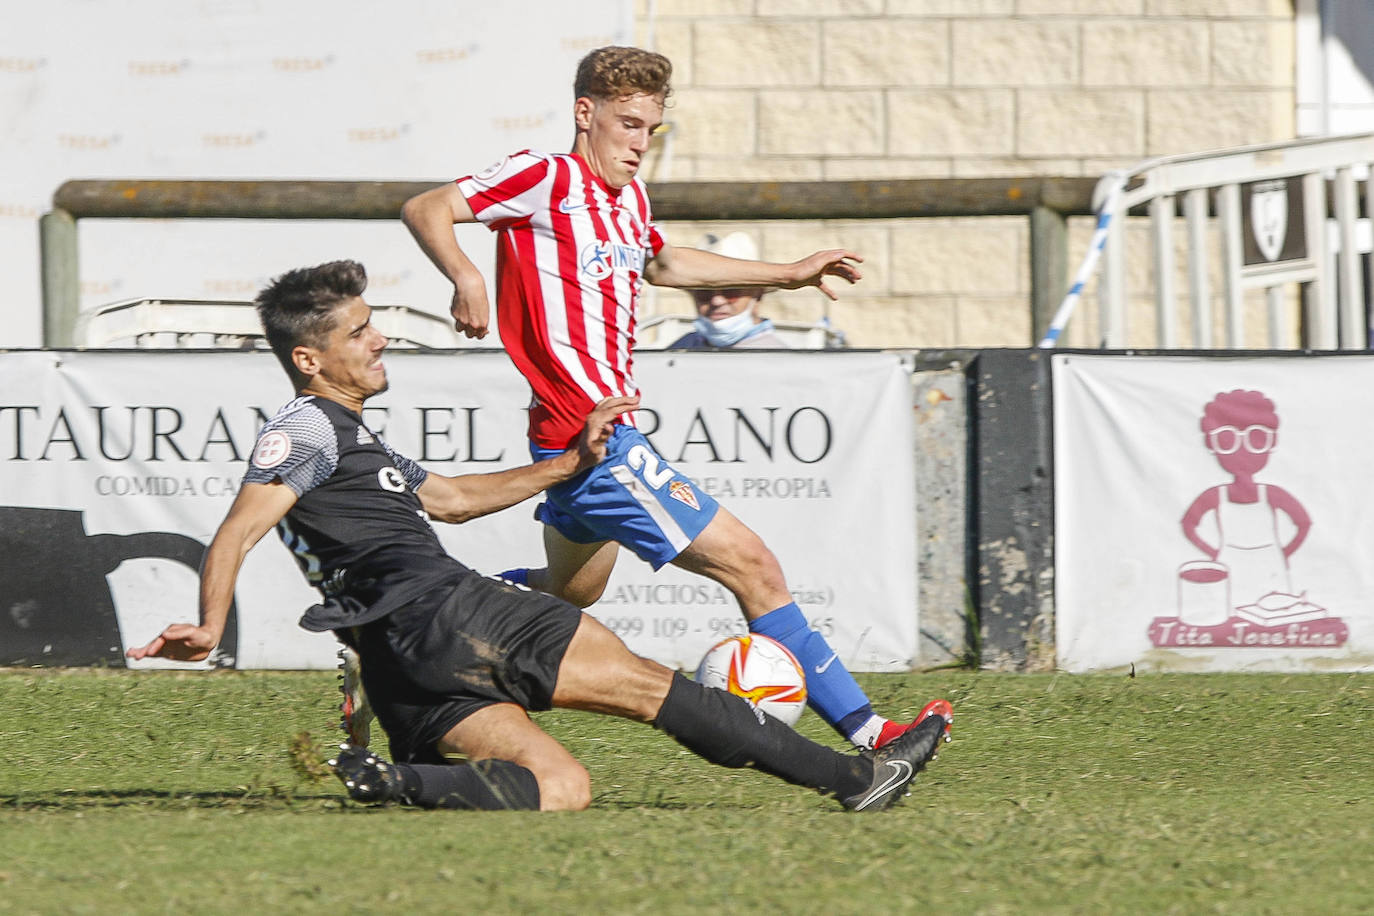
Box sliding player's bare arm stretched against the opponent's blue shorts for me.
[416,397,639,522]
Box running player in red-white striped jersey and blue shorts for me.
[401,47,949,748]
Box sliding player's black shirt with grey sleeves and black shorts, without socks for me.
[243,396,581,762]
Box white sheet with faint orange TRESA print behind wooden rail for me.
[0,0,632,347]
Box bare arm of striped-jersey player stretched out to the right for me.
[644,246,863,299]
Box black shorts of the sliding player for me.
[339,573,583,764]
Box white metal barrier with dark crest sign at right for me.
[1041,135,1374,350]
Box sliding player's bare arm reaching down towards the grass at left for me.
[125,482,295,662]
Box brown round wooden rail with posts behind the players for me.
[40,177,1095,347]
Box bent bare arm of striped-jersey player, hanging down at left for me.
[401,181,492,341]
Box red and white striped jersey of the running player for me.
[458,150,664,449]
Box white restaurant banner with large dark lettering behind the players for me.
[0,350,916,672]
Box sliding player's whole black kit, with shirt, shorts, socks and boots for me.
[243,396,890,809]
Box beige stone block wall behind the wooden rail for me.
[636,0,1294,347]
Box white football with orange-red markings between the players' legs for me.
[697,634,807,725]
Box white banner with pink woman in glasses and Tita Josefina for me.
[1054,354,1374,672]
